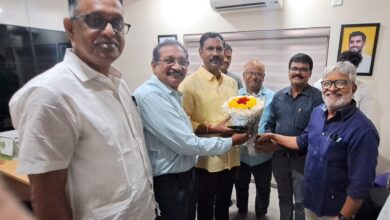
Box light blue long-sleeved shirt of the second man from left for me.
[134,75,232,176]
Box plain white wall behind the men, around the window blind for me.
[0,0,390,173]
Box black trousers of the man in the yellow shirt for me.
[196,167,237,220]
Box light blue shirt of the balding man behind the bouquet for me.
[238,86,275,166]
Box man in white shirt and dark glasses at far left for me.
[9,0,156,220]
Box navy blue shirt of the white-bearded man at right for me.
[297,102,379,216]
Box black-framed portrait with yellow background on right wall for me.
[337,23,380,76]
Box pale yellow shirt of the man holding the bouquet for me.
[179,67,240,172]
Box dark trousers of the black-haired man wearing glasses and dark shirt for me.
[272,151,306,220]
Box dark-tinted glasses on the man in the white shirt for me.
[71,13,131,34]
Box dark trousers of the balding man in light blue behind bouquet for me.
[235,160,272,216]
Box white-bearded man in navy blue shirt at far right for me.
[256,62,379,220]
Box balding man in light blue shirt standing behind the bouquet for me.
[235,60,275,217]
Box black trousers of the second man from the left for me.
[153,169,196,220]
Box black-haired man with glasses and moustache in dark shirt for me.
[265,53,323,220]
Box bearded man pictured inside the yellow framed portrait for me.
[349,31,372,73]
